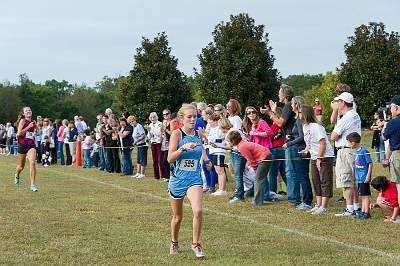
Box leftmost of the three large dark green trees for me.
[119,32,191,121]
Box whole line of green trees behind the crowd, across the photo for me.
[0,14,400,127]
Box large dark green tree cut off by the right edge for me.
[339,22,400,125]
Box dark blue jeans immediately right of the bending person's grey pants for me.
[268,147,286,193]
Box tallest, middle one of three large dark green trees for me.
[196,14,279,106]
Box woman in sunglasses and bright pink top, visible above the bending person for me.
[243,106,273,149]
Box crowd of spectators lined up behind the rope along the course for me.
[0,84,400,223]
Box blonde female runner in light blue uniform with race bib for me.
[168,104,211,258]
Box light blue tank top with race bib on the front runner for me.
[171,129,202,179]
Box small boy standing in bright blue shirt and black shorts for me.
[346,132,372,220]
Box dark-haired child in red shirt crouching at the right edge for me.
[371,176,400,224]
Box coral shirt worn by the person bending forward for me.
[237,140,271,171]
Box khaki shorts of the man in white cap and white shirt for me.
[335,148,356,188]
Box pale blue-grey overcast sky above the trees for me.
[0,0,400,86]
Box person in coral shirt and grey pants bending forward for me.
[227,131,273,206]
